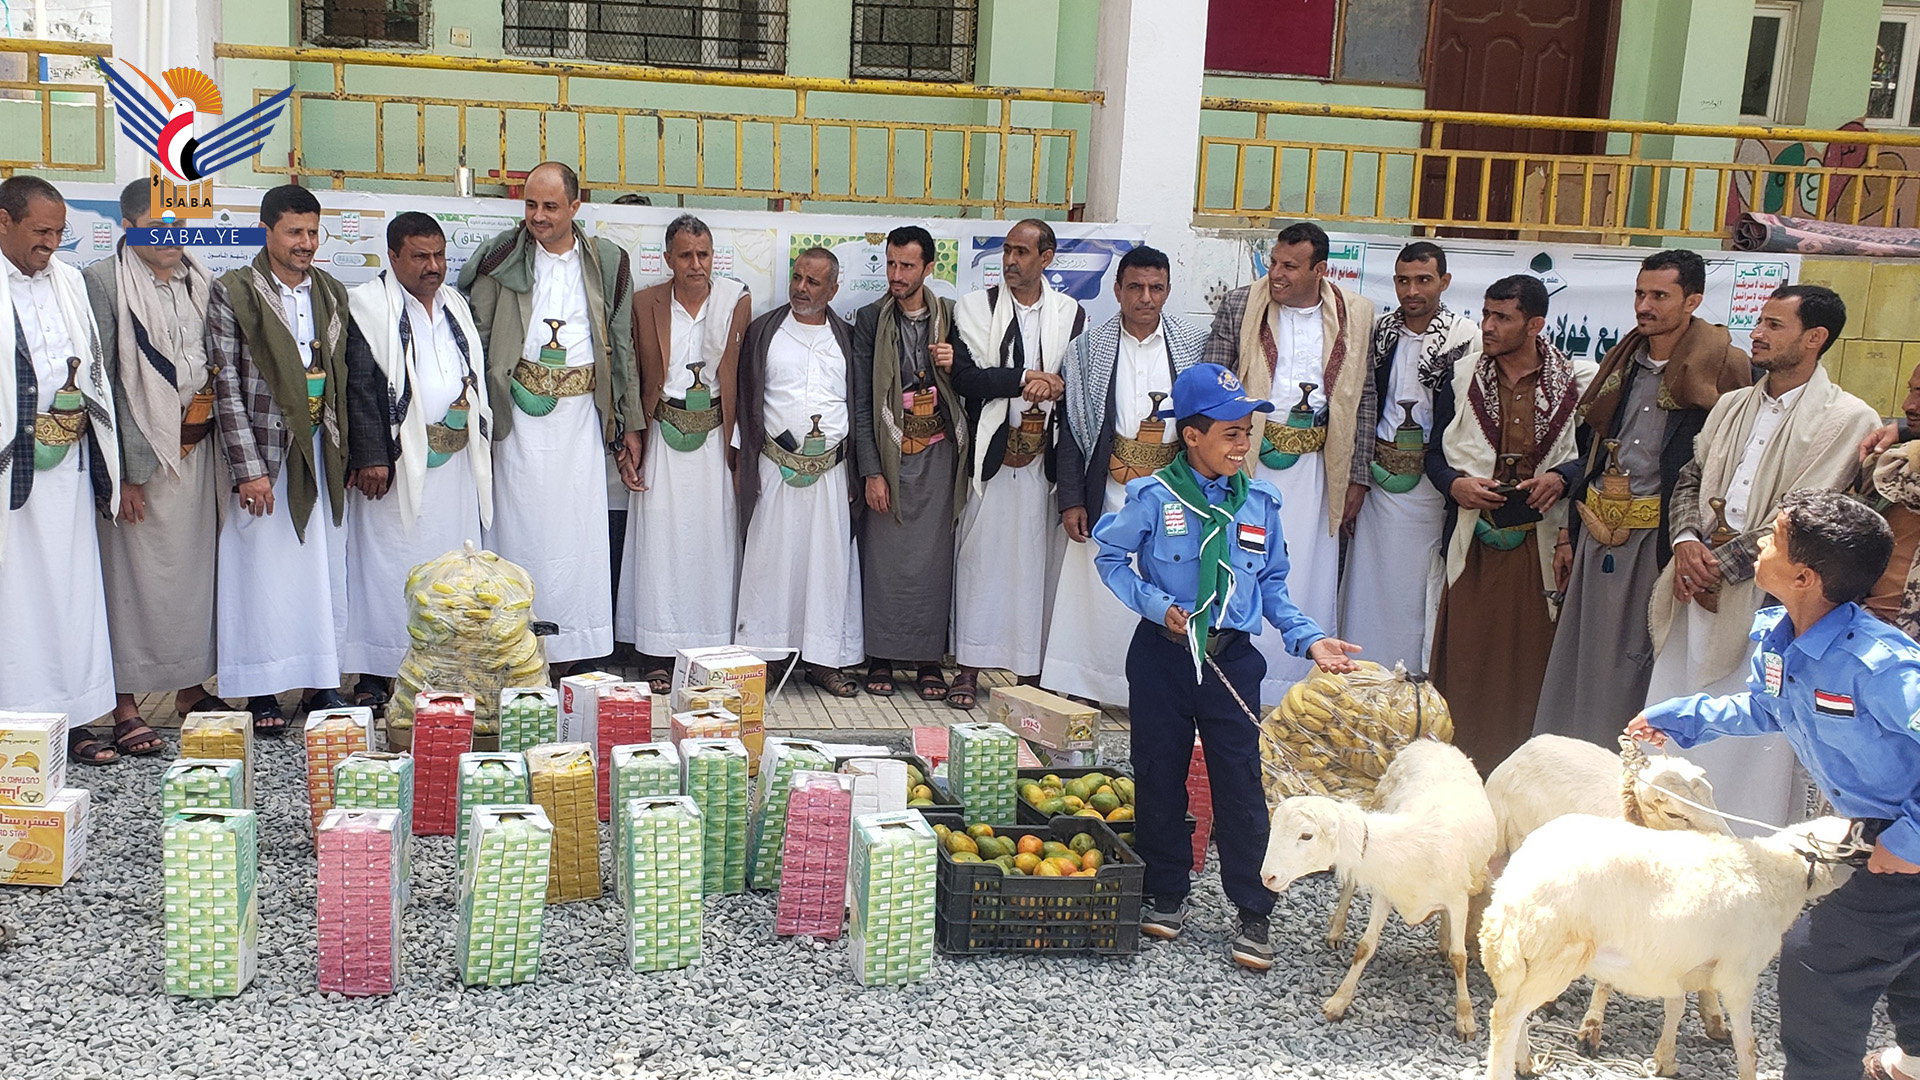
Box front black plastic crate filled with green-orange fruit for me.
[927,815,1146,955]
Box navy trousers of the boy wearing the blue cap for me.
[1127,621,1275,915]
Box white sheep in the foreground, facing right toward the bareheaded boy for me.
[1480,815,1847,1080]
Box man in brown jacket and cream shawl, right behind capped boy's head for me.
[1206,221,1379,705]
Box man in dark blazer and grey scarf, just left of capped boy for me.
[1041,246,1206,705]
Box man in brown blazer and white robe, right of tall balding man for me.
[614,213,753,694]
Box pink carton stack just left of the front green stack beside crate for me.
[768,768,854,940]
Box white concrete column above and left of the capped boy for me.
[1087,0,1208,239]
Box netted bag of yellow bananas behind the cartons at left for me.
[386,542,547,742]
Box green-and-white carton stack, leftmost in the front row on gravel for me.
[159,809,259,997]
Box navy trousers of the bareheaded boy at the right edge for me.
[1780,869,1920,1080]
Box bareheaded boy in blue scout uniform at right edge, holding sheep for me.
[1626,490,1920,1080]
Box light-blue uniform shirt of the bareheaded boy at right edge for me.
[1645,603,1920,863]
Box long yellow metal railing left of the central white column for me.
[215,44,1102,213]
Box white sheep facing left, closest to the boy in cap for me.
[1260,740,1494,1040]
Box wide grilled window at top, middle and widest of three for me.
[503,0,787,71]
